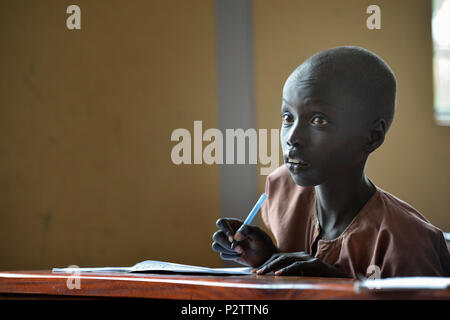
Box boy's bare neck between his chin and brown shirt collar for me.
[314,165,376,240]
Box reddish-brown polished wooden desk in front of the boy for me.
[0,271,450,300]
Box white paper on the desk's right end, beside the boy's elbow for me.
[355,277,450,290]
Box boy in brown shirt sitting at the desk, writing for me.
[212,47,450,278]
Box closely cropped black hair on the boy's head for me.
[294,46,397,132]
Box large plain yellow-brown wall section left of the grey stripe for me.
[0,0,220,270]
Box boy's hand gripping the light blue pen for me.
[212,218,277,267]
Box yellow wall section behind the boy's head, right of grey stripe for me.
[253,0,450,231]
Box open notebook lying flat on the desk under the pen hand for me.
[52,260,252,275]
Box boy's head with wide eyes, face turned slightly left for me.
[281,47,397,186]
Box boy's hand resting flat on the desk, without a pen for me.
[256,252,349,278]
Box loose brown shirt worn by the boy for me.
[261,165,450,278]
